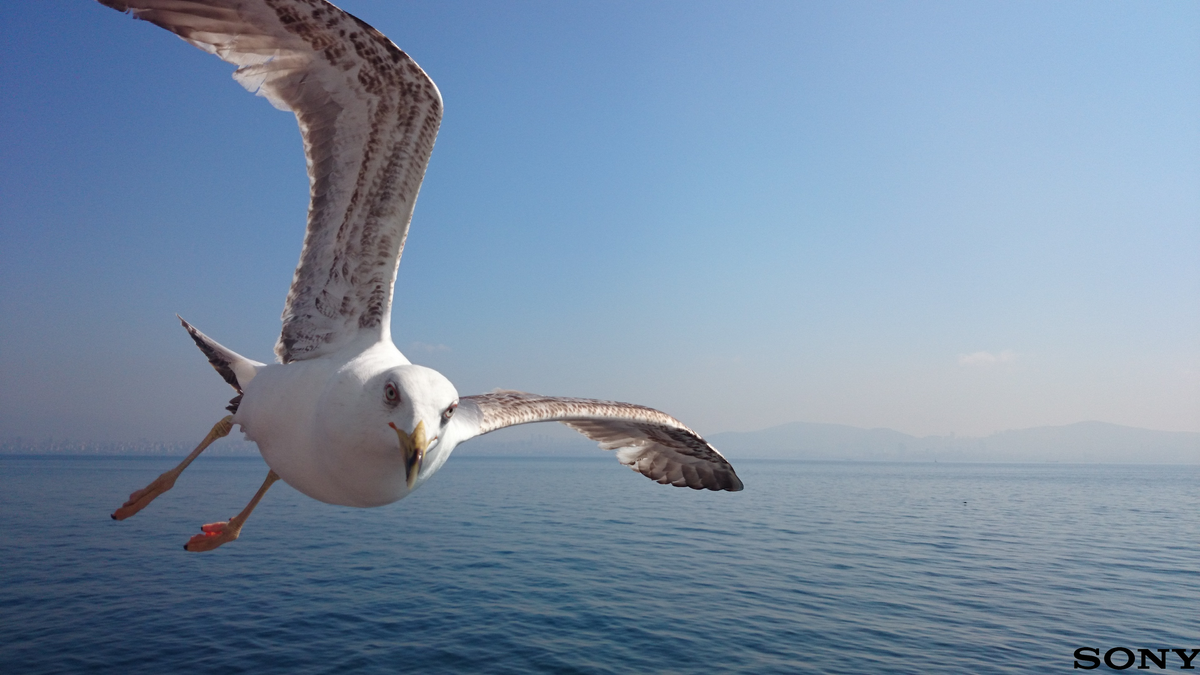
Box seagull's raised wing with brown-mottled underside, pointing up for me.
[100,0,442,363]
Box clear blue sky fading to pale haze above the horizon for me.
[0,0,1200,442]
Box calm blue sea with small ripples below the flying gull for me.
[0,454,1200,674]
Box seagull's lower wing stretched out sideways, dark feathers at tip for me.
[454,392,742,491]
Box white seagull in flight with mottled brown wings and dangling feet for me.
[100,0,743,551]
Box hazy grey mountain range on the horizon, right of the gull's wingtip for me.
[709,422,1200,464]
